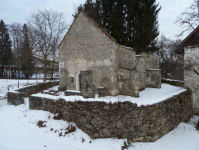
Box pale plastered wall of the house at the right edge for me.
[184,47,199,115]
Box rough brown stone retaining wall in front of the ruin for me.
[29,90,192,142]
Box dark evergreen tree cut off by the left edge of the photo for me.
[0,20,13,78]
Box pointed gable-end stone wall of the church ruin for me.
[59,13,118,95]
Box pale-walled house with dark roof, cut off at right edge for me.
[175,26,199,114]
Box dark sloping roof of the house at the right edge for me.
[174,26,199,54]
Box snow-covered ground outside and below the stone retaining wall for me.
[0,80,199,150]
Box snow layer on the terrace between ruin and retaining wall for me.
[32,84,186,107]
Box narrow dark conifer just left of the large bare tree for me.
[20,24,34,79]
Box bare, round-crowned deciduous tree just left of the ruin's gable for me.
[27,9,67,81]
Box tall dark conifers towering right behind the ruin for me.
[73,0,161,53]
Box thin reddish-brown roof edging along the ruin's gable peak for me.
[58,11,117,48]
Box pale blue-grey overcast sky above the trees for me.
[0,0,194,39]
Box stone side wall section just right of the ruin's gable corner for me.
[116,45,139,97]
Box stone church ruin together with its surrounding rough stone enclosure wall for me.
[8,12,193,142]
